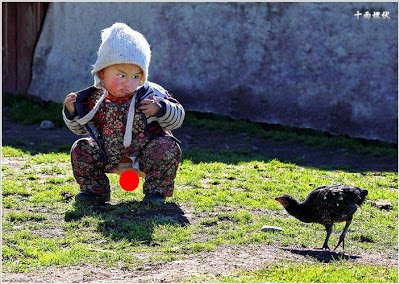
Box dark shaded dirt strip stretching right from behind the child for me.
[173,126,397,172]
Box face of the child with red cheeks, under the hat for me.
[99,63,143,98]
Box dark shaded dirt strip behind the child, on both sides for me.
[2,115,397,172]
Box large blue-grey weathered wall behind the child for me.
[29,2,398,143]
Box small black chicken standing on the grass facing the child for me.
[275,184,368,250]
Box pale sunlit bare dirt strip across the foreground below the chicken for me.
[2,244,397,283]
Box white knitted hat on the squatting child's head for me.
[92,23,151,88]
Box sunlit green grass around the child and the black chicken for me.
[2,146,398,282]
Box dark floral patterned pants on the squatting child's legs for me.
[71,137,182,197]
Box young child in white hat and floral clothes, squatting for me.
[63,23,185,204]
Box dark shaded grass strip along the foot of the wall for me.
[3,94,398,158]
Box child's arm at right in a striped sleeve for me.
[139,82,185,131]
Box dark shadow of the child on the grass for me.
[65,201,190,246]
